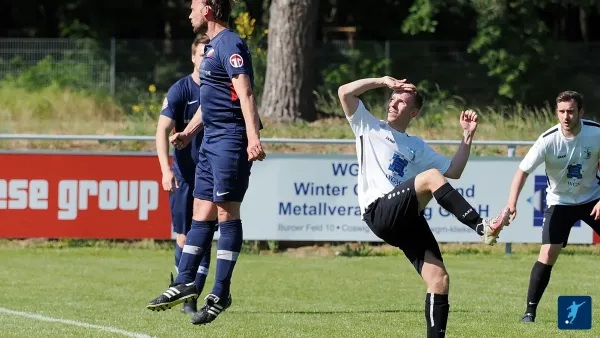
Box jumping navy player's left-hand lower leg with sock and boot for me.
[146,198,217,311]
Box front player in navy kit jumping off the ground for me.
[148,0,265,324]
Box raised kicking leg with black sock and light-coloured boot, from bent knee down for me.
[415,169,509,245]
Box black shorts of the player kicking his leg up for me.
[363,178,443,274]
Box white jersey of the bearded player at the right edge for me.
[519,120,600,206]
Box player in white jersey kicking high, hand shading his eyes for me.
[338,76,509,338]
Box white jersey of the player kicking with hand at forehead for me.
[348,100,450,214]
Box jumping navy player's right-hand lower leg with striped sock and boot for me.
[192,202,243,325]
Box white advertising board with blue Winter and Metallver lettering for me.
[236,154,593,243]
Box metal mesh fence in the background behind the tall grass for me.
[0,39,600,109]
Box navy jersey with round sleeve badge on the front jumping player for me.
[200,29,262,134]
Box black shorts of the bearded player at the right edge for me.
[542,200,600,248]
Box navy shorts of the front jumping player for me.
[194,133,252,203]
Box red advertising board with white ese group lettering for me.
[0,153,171,239]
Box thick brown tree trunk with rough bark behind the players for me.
[261,0,319,121]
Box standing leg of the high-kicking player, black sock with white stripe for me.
[421,251,450,338]
